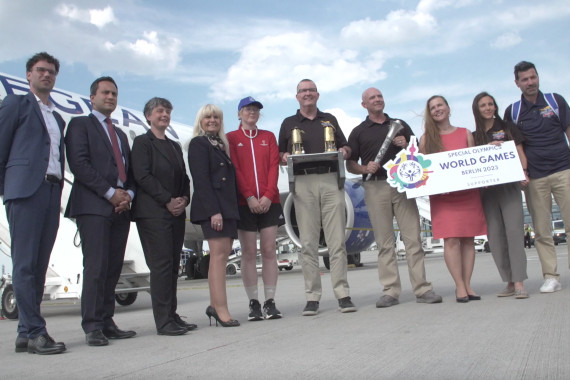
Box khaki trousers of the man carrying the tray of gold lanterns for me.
[293,173,350,301]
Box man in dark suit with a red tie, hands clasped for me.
[65,77,136,346]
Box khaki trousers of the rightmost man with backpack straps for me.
[526,169,570,280]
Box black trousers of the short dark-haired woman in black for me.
[136,215,185,329]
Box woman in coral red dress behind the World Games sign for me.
[420,95,487,303]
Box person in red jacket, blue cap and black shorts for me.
[227,96,285,321]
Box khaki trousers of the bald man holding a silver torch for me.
[363,180,432,299]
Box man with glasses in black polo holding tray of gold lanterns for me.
[279,79,356,315]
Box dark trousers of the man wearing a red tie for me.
[76,213,131,333]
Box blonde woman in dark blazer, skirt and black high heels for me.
[188,104,239,327]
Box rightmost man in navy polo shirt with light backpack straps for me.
[505,61,570,293]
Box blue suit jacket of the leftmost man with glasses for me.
[0,92,65,202]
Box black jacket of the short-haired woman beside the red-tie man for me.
[131,130,190,218]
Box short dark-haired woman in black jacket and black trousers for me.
[131,98,196,335]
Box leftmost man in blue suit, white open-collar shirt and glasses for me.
[0,53,65,355]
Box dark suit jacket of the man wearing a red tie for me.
[65,114,135,218]
